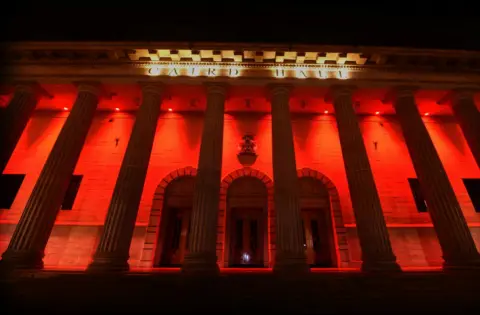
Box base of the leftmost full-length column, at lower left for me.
[0,249,44,271]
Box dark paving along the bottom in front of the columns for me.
[0,270,480,314]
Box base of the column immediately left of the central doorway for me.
[181,253,220,276]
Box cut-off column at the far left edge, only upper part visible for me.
[0,82,46,174]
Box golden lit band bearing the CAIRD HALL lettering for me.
[146,65,350,80]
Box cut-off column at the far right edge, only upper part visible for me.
[451,89,480,167]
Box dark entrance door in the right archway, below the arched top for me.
[301,209,333,267]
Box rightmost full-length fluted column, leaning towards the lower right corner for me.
[392,87,480,268]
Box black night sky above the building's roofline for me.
[0,0,480,50]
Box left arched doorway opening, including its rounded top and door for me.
[153,176,195,267]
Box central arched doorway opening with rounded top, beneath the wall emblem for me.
[225,176,268,267]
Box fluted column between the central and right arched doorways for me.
[269,85,309,274]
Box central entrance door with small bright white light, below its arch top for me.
[230,208,264,267]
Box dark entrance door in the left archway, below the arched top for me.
[161,208,192,266]
